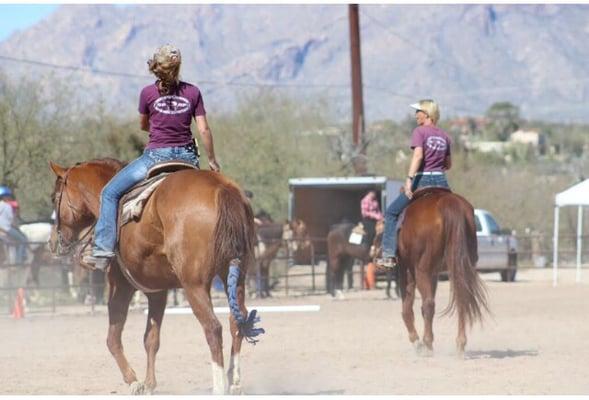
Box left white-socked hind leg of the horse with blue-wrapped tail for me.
[184,284,227,394]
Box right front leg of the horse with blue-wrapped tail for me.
[143,290,168,393]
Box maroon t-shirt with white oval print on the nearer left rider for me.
[139,81,206,149]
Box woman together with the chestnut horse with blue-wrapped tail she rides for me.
[50,46,263,394]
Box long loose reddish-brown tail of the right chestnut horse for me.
[440,195,489,326]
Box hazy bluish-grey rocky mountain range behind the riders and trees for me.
[0,4,589,122]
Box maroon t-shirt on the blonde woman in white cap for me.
[411,126,452,172]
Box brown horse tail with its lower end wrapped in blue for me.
[213,185,264,343]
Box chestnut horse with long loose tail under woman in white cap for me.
[398,188,489,356]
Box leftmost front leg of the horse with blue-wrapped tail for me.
[106,265,137,390]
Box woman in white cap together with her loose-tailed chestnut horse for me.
[377,100,487,354]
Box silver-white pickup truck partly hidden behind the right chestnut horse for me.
[474,208,517,282]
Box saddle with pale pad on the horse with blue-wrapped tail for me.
[117,161,198,228]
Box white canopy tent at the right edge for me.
[552,179,589,286]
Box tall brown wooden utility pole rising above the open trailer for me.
[348,4,366,174]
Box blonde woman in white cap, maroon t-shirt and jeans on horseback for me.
[376,99,452,268]
